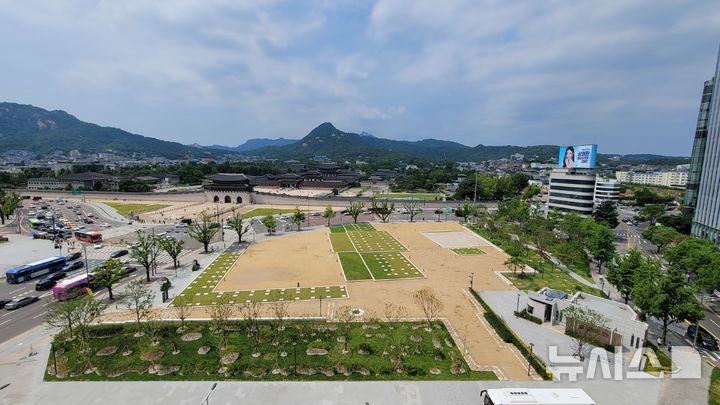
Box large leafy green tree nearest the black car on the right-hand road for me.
[632,264,704,342]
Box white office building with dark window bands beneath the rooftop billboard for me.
[548,169,596,216]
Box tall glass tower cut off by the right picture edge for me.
[691,48,720,243]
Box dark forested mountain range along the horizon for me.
[0,102,689,164]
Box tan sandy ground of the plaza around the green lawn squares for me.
[200,223,528,380]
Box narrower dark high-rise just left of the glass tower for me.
[683,78,714,214]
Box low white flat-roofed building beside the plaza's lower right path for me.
[527,287,648,349]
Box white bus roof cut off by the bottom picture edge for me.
[480,388,595,405]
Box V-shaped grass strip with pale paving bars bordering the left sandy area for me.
[176,252,347,305]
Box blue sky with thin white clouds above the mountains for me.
[0,0,720,155]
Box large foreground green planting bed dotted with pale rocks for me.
[45,320,497,381]
